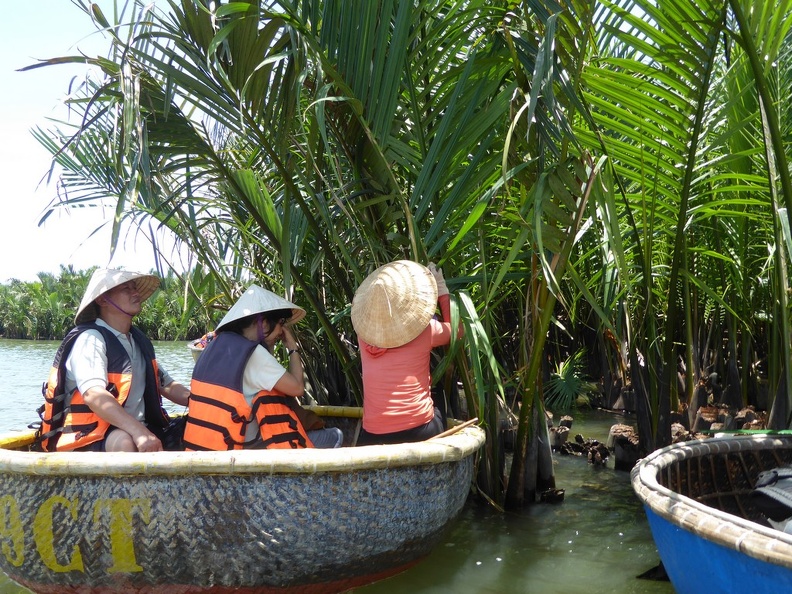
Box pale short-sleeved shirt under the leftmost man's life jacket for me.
[64,319,173,421]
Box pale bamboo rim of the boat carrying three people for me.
[0,407,485,476]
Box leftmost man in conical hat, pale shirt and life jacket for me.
[42,269,190,452]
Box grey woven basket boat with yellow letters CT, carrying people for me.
[0,407,484,594]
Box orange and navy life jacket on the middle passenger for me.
[184,332,313,451]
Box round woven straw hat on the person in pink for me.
[352,260,437,349]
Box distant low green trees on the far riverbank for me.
[0,266,214,340]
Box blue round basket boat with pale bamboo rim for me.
[632,435,792,594]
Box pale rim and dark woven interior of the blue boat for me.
[632,435,792,568]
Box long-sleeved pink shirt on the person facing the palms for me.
[358,295,451,434]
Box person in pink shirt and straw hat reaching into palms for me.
[352,260,458,445]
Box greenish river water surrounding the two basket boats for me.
[0,339,673,594]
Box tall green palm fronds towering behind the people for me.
[24,0,792,506]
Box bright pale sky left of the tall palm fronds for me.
[0,0,176,284]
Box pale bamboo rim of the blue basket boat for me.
[631,435,792,566]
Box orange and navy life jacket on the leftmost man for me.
[39,322,170,452]
